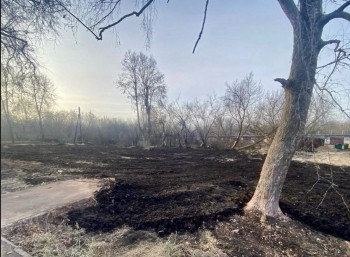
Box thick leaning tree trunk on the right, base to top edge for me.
[245,0,322,217]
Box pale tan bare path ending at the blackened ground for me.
[1,179,99,227]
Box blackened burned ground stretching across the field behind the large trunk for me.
[1,145,350,240]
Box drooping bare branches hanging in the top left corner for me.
[0,0,64,72]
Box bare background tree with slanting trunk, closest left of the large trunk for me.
[224,73,262,148]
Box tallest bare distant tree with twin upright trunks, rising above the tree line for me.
[117,51,167,141]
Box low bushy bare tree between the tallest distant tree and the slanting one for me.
[187,94,221,147]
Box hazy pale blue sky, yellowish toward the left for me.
[38,0,350,119]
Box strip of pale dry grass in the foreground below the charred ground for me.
[5,216,232,257]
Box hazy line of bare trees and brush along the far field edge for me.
[1,51,350,146]
